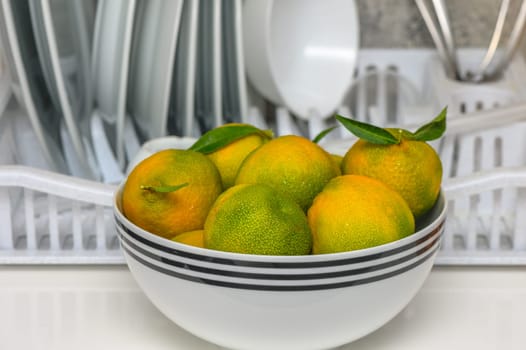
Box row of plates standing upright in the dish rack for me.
[0,0,258,183]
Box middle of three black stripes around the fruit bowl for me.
[118,226,443,280]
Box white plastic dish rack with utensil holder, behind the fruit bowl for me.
[0,49,526,265]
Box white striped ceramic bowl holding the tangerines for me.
[114,185,446,350]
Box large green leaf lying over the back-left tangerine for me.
[189,124,273,154]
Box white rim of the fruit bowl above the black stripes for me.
[113,180,448,267]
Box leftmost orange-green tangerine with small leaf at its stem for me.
[122,149,222,238]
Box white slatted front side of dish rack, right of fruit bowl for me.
[444,166,526,265]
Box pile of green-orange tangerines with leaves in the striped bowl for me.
[122,109,446,255]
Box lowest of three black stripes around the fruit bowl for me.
[123,244,440,292]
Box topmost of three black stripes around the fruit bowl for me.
[115,216,445,268]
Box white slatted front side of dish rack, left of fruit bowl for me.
[0,165,119,264]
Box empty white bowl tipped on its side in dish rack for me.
[243,0,359,119]
